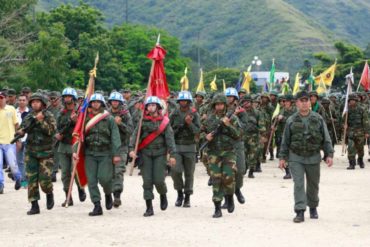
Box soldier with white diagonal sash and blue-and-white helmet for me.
[73,93,121,216]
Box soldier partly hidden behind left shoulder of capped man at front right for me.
[276,94,296,179]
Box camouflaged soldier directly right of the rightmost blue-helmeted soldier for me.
[240,95,266,178]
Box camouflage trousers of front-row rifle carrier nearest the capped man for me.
[208,150,237,202]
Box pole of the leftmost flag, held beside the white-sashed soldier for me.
[65,53,99,208]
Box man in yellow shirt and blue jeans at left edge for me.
[0,91,21,194]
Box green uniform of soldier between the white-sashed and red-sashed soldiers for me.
[110,103,134,207]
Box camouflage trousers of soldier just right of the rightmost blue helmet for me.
[244,133,260,169]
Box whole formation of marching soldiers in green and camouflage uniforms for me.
[0,88,370,222]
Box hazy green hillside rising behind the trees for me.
[35,0,370,72]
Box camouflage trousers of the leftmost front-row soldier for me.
[25,152,53,202]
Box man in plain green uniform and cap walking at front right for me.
[279,91,334,223]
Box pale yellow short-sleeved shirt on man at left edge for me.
[0,105,18,144]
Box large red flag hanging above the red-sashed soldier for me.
[147,44,170,100]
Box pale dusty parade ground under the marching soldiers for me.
[0,146,370,246]
